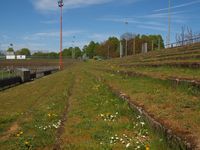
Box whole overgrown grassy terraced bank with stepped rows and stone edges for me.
[0,44,200,150]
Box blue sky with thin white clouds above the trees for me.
[0,0,200,52]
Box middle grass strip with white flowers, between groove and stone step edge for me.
[58,67,168,150]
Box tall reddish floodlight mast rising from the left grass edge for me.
[58,0,64,70]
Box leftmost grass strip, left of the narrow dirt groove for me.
[0,67,73,149]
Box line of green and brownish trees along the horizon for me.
[2,33,164,58]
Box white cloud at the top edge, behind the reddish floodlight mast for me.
[31,0,113,11]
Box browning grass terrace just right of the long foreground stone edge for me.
[88,67,200,146]
